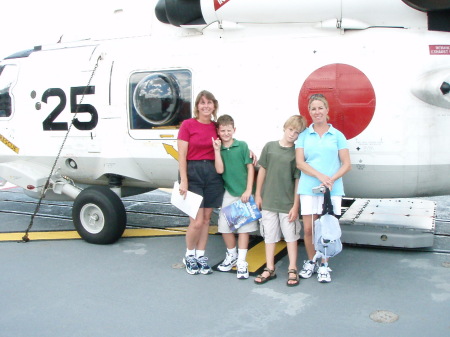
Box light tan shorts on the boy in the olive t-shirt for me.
[261,210,302,243]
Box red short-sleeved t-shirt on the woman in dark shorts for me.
[178,118,217,160]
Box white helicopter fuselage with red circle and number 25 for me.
[0,0,450,242]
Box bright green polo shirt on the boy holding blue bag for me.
[220,139,252,197]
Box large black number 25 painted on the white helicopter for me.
[42,86,98,131]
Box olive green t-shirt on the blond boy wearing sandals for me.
[258,141,300,213]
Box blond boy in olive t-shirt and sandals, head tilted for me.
[254,115,306,287]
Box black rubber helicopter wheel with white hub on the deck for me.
[72,186,127,245]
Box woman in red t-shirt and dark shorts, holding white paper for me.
[177,90,224,275]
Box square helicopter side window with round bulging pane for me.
[129,69,192,129]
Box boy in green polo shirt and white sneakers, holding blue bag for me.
[213,115,258,279]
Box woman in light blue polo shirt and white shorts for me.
[295,94,351,283]
